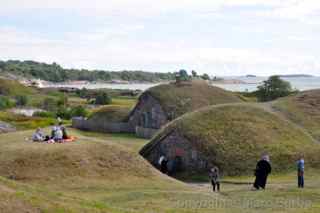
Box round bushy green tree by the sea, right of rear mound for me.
[257,76,293,101]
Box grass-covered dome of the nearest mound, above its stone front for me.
[145,104,320,175]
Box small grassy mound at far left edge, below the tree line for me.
[0,78,35,96]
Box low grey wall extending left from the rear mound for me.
[72,117,135,133]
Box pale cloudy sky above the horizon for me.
[0,0,320,76]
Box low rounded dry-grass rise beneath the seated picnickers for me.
[0,129,156,181]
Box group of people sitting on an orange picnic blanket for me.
[32,119,75,143]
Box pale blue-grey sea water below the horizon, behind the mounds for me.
[44,76,320,92]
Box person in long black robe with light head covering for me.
[253,155,271,190]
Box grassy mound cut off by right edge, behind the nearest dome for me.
[273,90,320,141]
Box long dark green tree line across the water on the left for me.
[0,60,175,82]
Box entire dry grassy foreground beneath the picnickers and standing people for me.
[0,130,320,213]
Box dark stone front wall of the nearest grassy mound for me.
[144,131,209,173]
